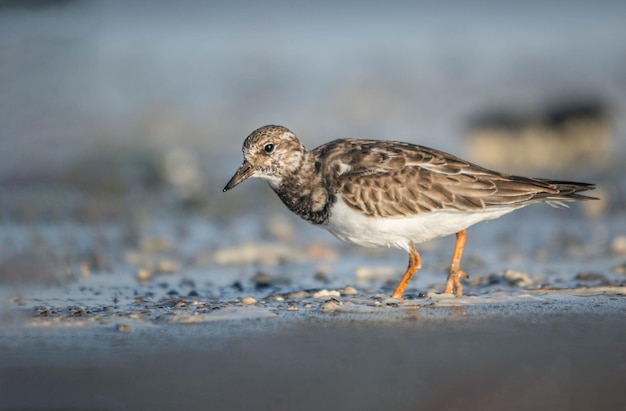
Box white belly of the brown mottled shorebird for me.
[324,197,521,251]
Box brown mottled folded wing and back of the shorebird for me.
[316,139,593,217]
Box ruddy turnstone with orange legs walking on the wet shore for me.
[224,125,595,299]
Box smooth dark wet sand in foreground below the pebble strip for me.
[0,295,626,410]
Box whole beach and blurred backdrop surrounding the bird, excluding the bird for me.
[0,0,626,410]
